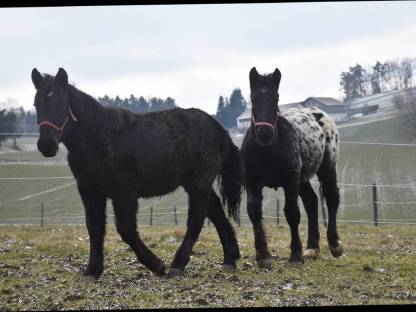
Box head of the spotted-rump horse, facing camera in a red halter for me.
[250,67,281,145]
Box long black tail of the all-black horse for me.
[218,135,243,221]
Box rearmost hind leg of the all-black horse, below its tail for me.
[208,190,240,270]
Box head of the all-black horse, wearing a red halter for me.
[32,68,76,157]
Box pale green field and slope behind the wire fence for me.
[0,112,416,224]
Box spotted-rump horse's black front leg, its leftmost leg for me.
[247,187,272,268]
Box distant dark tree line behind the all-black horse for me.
[0,94,176,145]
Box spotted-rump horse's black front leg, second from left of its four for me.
[283,177,304,263]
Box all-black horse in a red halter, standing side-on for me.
[32,68,242,278]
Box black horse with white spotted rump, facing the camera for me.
[241,67,343,267]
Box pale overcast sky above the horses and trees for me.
[0,1,416,114]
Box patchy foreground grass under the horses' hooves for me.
[0,225,416,311]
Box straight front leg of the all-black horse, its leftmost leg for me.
[79,188,106,278]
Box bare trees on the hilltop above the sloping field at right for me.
[340,58,416,101]
